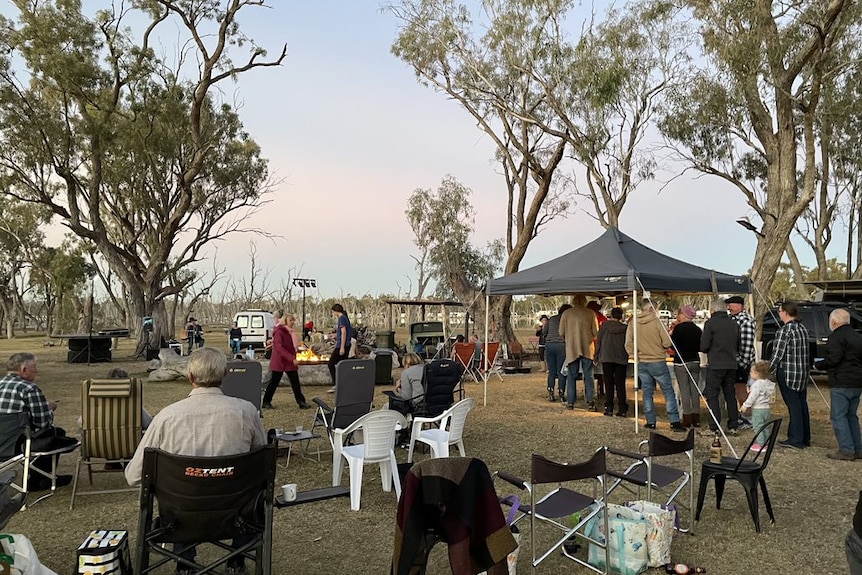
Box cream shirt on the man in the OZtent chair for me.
[126,387,266,485]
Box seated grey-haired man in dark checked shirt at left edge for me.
[0,353,77,491]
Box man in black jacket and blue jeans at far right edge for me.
[814,308,862,461]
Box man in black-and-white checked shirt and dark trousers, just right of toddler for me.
[770,301,811,449]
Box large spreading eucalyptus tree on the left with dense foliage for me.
[0,0,286,353]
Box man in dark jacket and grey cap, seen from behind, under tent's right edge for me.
[700,299,739,435]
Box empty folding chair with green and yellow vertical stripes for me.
[69,378,143,509]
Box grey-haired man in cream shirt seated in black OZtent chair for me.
[126,347,266,575]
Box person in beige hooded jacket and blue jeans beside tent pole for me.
[626,301,685,431]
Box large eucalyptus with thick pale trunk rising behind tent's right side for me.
[656,0,859,316]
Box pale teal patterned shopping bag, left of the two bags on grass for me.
[586,503,649,575]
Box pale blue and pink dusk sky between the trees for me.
[44,0,840,297]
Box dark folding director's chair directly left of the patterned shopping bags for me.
[497,449,611,573]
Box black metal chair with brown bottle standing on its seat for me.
[694,418,781,533]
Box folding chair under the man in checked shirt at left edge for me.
[0,412,81,509]
